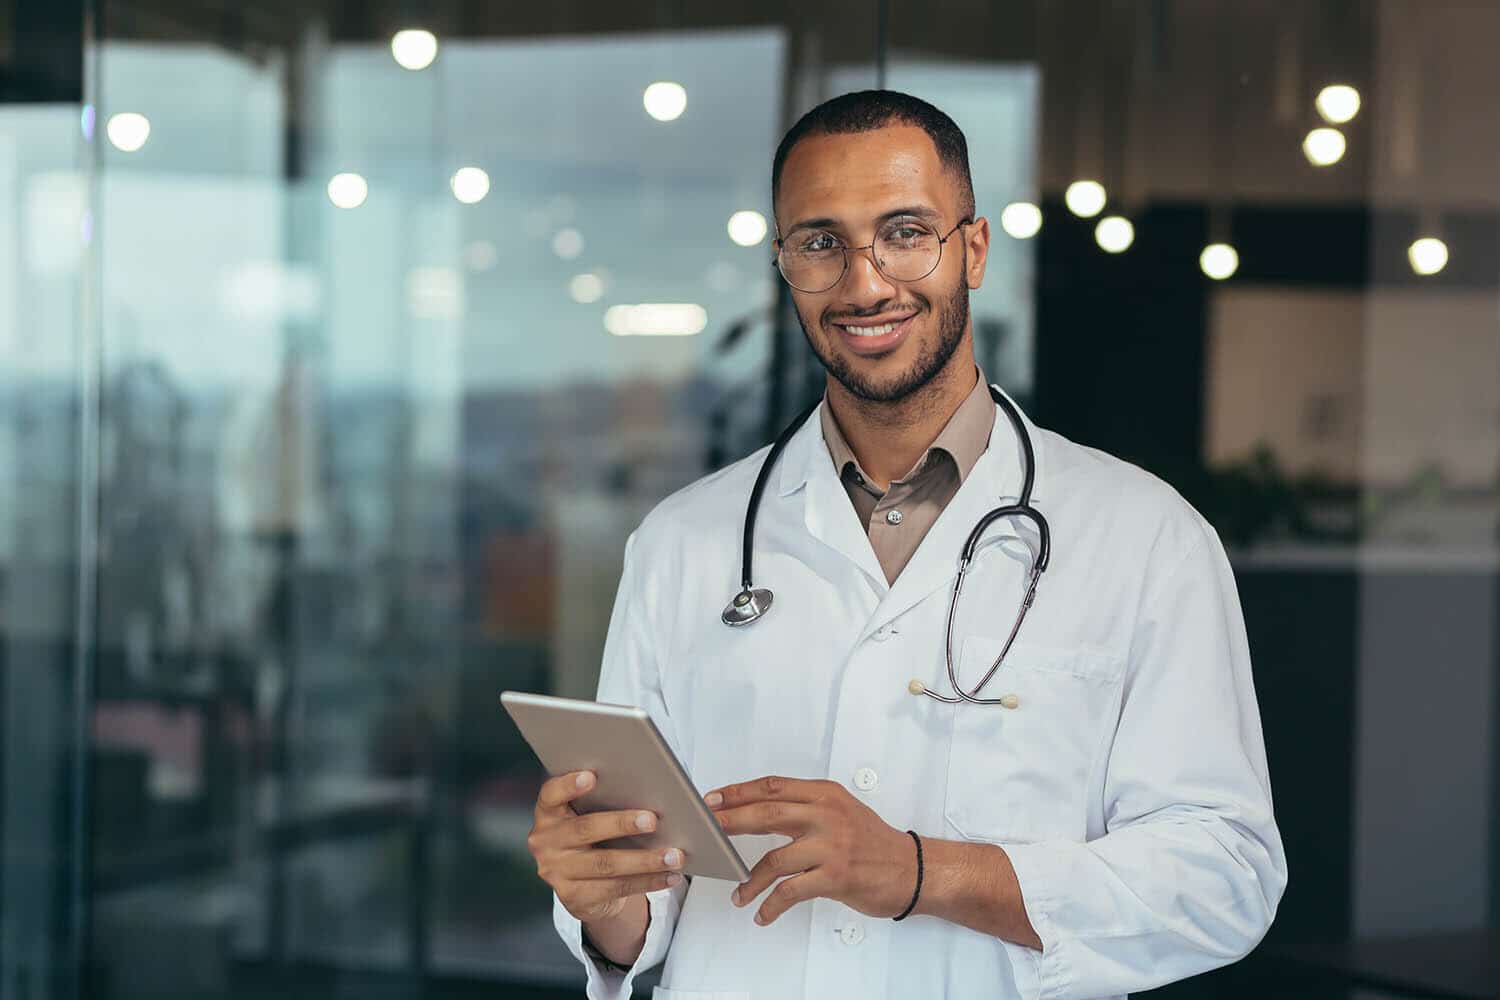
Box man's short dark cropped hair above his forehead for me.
[771,90,974,224]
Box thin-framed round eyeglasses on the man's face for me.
[771,217,974,292]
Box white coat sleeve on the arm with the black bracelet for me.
[1004,519,1287,1000]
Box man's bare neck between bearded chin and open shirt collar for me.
[828,351,980,490]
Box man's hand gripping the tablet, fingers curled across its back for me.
[527,771,683,924]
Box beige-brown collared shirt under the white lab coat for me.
[821,372,995,583]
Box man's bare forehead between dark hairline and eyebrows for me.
[776,124,956,226]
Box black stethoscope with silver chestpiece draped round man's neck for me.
[720,385,1052,708]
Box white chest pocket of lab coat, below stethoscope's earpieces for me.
[944,636,1124,843]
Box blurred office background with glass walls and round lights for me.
[0,0,1500,1000]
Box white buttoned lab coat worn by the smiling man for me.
[554,389,1287,1000]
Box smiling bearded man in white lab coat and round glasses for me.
[530,91,1286,1000]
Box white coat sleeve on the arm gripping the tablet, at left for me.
[552,534,687,1000]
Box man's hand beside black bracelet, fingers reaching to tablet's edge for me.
[704,777,917,925]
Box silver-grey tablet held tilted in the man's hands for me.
[500,691,750,882]
